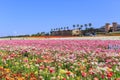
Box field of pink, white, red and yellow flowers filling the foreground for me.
[0,40,120,80]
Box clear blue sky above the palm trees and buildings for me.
[0,0,120,36]
